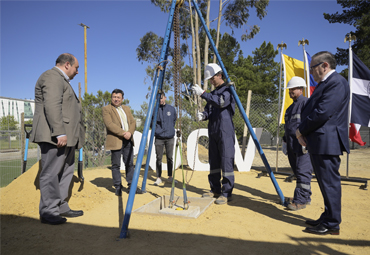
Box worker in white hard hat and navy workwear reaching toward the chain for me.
[192,64,235,204]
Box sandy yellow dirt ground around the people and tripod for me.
[0,149,370,255]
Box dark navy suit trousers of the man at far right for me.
[311,154,342,229]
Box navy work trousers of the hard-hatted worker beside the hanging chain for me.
[208,133,235,197]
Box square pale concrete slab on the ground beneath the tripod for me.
[133,196,215,219]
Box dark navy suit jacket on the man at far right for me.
[298,72,350,155]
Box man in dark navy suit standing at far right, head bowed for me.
[296,51,350,235]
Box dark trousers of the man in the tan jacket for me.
[111,139,134,189]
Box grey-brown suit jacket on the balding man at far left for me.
[30,67,85,149]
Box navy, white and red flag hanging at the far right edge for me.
[349,53,370,146]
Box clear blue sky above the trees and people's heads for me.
[0,0,355,111]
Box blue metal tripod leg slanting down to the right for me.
[192,0,285,204]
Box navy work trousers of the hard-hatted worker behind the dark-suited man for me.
[288,149,312,204]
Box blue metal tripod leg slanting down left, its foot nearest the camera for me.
[120,0,176,238]
